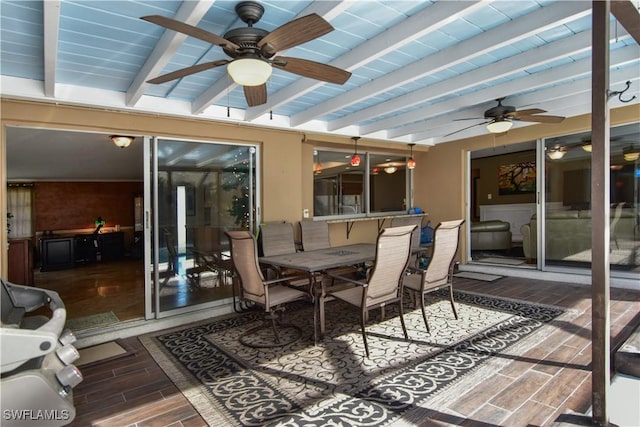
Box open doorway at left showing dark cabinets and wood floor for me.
[6,127,145,330]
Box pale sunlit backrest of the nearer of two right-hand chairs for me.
[367,225,416,306]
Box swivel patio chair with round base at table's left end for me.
[225,230,309,348]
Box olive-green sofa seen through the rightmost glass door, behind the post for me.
[520,208,640,261]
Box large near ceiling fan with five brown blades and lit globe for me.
[140,1,351,107]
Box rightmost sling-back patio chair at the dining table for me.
[404,219,464,332]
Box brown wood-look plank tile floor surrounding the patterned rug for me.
[66,277,640,427]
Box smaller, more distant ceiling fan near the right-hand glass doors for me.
[445,98,564,136]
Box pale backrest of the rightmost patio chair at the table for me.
[425,219,464,283]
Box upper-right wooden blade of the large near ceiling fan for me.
[258,13,333,55]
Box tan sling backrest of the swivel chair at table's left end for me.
[225,230,266,304]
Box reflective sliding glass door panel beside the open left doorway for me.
[149,138,257,317]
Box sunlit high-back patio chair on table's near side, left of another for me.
[328,225,416,357]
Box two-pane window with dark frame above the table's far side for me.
[313,148,410,217]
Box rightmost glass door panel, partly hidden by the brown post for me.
[543,124,640,275]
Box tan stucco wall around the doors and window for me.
[0,99,638,275]
